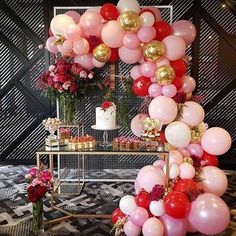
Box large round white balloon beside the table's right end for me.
[165,121,191,148]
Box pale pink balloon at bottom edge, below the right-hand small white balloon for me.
[142,217,164,236]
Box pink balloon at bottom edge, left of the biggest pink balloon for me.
[160,214,188,236]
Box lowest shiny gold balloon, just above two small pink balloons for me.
[155,65,175,85]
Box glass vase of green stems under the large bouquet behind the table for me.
[61,97,76,124]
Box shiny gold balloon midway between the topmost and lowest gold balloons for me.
[143,40,164,62]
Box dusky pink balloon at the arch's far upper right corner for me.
[172,20,196,45]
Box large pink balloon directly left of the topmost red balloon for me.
[79,11,103,37]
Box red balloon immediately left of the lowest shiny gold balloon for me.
[132,76,152,97]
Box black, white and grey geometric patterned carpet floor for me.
[0,166,236,236]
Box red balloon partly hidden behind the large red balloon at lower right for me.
[173,179,198,197]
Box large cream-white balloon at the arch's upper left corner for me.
[50,14,75,37]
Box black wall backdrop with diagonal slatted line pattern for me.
[0,0,236,168]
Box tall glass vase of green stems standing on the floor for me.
[32,198,44,235]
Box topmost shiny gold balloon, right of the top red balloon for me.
[118,11,140,33]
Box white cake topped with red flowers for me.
[96,101,116,130]
